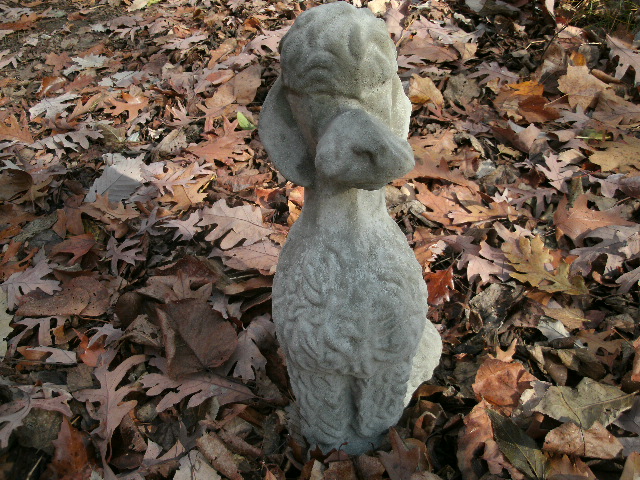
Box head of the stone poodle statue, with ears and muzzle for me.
[260,2,414,190]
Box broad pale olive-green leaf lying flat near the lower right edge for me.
[536,378,634,430]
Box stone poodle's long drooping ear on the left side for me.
[258,77,315,187]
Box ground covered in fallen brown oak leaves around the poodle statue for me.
[0,0,640,480]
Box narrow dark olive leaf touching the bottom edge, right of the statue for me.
[487,410,549,480]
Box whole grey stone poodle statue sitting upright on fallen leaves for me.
[260,2,442,453]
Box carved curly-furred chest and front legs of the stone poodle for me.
[273,225,427,450]
